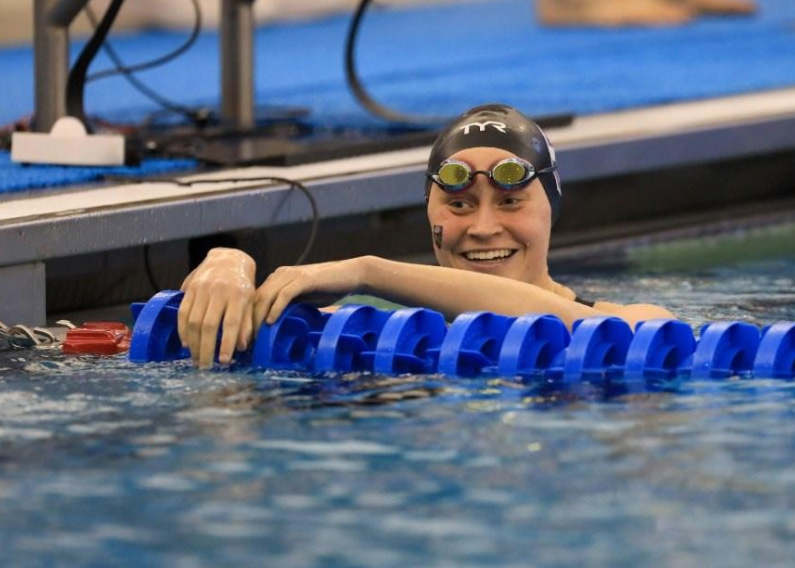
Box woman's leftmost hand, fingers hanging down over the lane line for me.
[178,248,256,369]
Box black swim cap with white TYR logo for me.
[425,104,562,223]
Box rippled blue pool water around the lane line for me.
[0,252,795,567]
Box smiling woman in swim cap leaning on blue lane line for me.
[179,104,674,367]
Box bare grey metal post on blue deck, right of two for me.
[219,0,254,130]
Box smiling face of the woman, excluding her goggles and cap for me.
[428,148,552,286]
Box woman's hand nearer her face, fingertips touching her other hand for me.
[254,257,367,329]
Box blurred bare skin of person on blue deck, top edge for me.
[536,0,756,27]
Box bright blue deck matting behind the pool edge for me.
[0,0,795,193]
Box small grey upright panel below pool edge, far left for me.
[0,262,47,326]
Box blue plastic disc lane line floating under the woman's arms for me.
[130,291,795,382]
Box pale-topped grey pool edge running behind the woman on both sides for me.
[0,89,795,325]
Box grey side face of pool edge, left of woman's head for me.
[0,170,430,265]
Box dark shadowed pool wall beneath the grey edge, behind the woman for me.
[46,153,795,320]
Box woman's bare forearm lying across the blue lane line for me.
[358,256,600,327]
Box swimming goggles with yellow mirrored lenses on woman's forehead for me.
[428,158,558,192]
